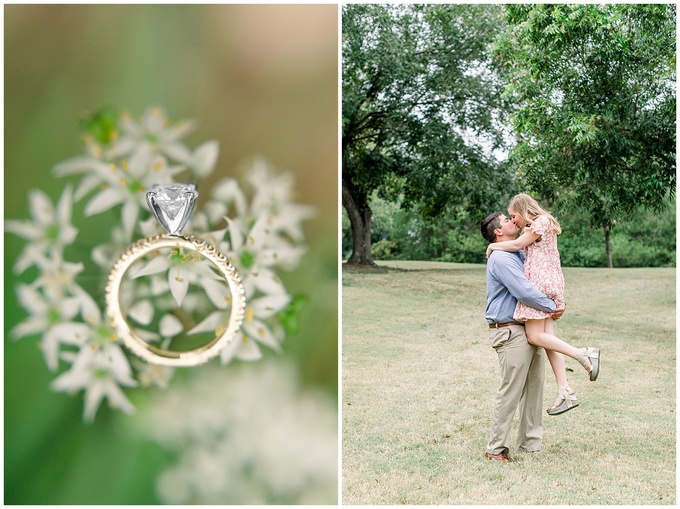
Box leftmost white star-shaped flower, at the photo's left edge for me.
[5,186,78,272]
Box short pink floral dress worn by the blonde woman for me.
[514,216,564,322]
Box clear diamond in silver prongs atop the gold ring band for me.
[146,184,198,235]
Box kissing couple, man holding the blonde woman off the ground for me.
[481,194,600,463]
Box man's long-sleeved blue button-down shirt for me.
[486,250,555,323]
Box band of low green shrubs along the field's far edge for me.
[358,192,676,267]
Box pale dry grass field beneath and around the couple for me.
[342,262,676,505]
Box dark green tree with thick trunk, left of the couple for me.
[342,4,509,265]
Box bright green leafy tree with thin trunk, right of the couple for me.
[494,4,676,267]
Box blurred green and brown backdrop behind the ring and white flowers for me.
[4,5,338,504]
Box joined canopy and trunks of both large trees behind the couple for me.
[342,4,676,266]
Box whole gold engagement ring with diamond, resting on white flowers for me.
[106,184,246,366]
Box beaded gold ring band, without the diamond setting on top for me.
[106,234,246,366]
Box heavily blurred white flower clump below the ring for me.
[138,361,338,505]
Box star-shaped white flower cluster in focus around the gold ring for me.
[5,107,314,421]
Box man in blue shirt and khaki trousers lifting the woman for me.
[481,212,564,463]
